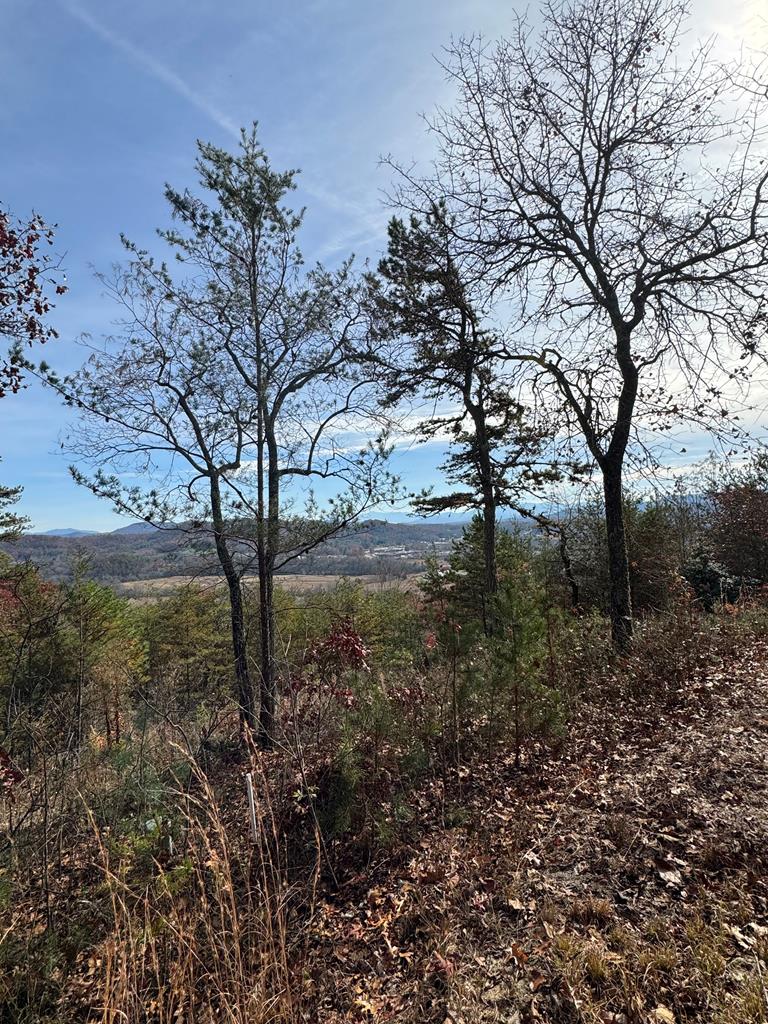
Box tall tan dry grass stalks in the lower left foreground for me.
[73,762,307,1024]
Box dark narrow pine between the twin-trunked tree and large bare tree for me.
[375,204,559,633]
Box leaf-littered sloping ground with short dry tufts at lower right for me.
[306,641,768,1024]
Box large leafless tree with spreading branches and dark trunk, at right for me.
[398,0,768,649]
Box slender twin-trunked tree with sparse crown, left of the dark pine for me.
[57,132,395,745]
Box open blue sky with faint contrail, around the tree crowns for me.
[0,0,764,529]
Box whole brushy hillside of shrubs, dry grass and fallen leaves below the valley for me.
[0,480,768,1024]
